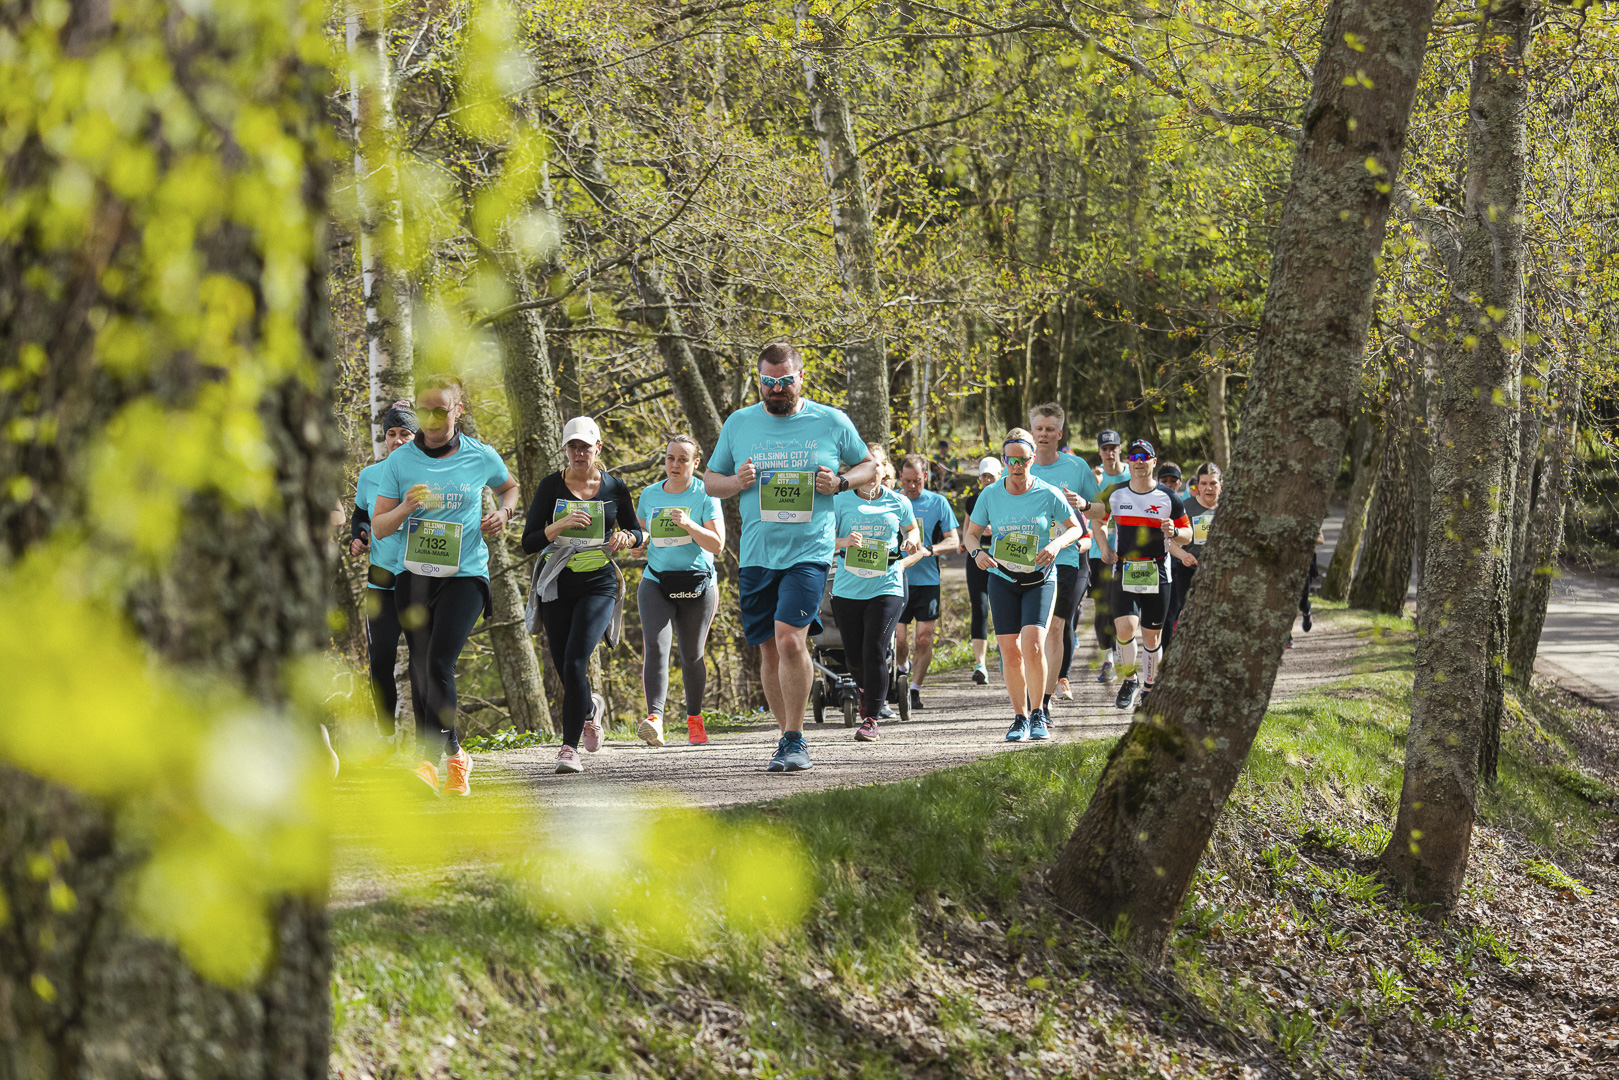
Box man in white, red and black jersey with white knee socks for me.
[1091,439,1192,709]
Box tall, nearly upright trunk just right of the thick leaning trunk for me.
[1383,0,1532,908]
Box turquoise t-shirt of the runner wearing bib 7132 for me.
[377,434,510,578]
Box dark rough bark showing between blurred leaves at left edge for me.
[0,3,342,1080]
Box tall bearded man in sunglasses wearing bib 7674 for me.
[703,342,877,772]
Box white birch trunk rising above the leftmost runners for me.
[345,3,413,461]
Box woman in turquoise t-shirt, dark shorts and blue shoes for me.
[967,427,1085,743]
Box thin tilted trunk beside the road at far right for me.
[1507,356,1580,690]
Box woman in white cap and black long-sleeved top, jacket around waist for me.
[523,416,646,772]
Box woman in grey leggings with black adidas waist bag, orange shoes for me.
[635,436,725,746]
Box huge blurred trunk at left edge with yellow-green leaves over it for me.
[0,3,340,1080]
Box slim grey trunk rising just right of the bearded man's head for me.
[797,12,889,445]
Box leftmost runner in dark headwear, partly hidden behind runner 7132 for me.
[348,402,421,733]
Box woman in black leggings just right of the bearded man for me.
[832,447,921,743]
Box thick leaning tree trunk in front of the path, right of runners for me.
[1051,0,1433,957]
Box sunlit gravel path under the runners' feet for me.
[474,617,1363,808]
